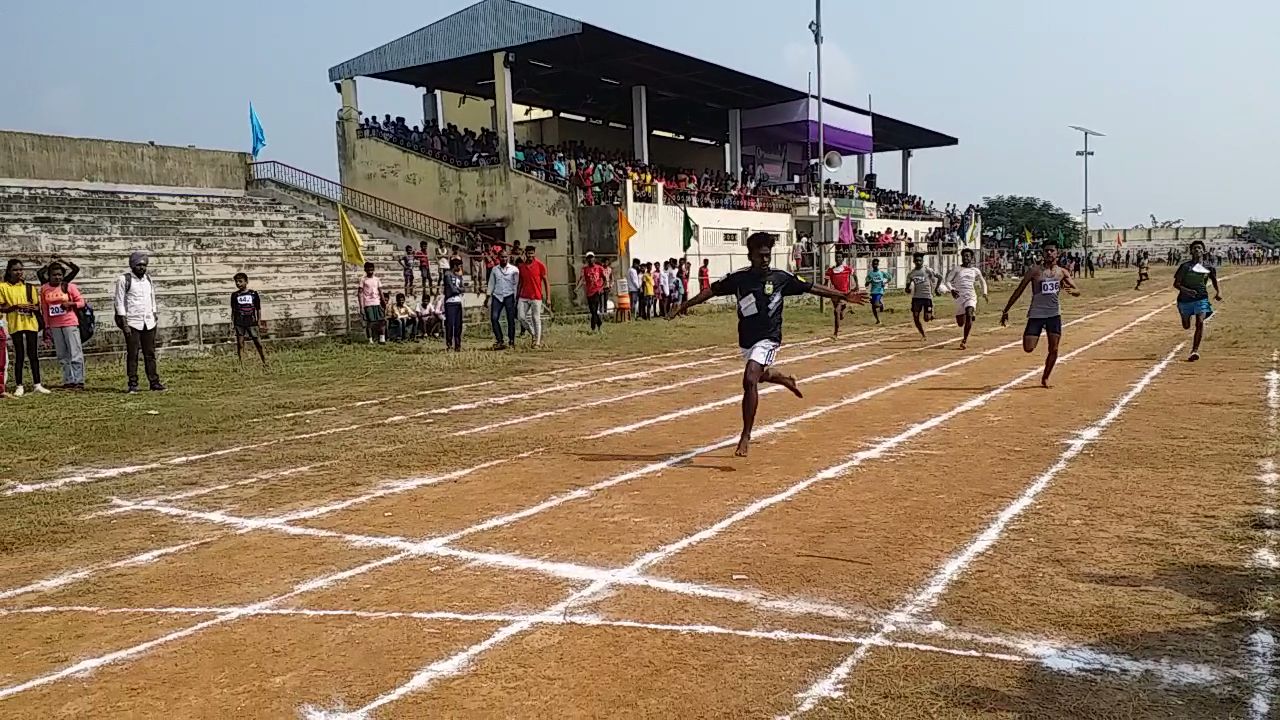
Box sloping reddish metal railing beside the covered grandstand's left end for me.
[248,160,484,246]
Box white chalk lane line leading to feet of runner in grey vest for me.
[302,307,1181,720]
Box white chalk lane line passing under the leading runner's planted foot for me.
[0,302,1160,698]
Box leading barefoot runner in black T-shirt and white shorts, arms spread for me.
[667,232,867,457]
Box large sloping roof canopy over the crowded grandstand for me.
[329,0,959,152]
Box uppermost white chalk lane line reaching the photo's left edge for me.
[15,331,844,495]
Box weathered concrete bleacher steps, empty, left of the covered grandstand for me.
[0,180,401,351]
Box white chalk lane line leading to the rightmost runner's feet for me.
[780,342,1187,719]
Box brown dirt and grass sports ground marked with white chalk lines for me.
[0,268,1280,720]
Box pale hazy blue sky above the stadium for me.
[0,0,1280,227]
